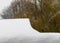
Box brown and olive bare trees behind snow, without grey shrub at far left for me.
[1,0,60,32]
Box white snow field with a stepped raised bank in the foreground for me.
[0,18,60,43]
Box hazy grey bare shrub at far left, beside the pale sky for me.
[2,6,14,19]
